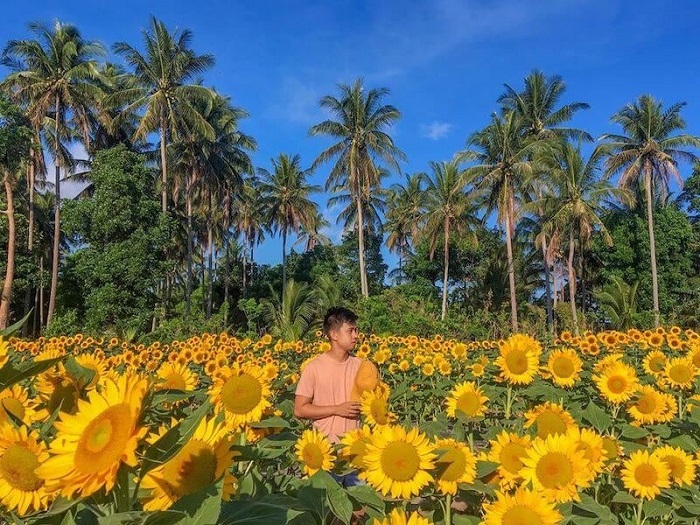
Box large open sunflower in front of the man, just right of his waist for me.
[360,426,435,499]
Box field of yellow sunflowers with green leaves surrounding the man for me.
[0,327,700,525]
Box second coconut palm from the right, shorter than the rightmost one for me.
[530,142,631,335]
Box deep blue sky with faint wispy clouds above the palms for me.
[0,0,700,263]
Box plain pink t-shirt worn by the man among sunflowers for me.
[296,354,362,443]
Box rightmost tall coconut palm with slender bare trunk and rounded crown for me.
[600,95,700,326]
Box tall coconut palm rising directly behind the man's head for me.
[309,79,405,297]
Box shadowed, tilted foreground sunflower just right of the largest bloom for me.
[141,418,237,511]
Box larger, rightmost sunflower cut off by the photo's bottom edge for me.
[481,487,562,525]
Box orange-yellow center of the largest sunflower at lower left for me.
[75,403,133,474]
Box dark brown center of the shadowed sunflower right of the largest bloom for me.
[165,440,216,497]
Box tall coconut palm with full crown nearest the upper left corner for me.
[2,21,104,323]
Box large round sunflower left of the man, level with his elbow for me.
[209,363,270,430]
